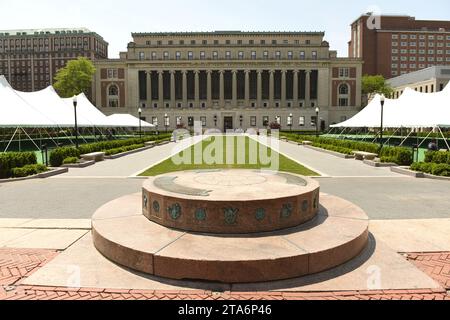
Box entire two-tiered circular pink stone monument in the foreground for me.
[92,169,369,283]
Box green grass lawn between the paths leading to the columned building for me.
[141,137,319,176]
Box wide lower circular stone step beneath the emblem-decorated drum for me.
[92,194,369,283]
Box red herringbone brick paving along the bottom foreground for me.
[0,248,450,300]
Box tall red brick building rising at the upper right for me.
[349,13,450,79]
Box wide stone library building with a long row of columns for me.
[94,32,362,131]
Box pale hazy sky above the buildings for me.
[0,0,450,58]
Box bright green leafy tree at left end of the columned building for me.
[53,57,95,98]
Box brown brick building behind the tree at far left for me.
[0,28,108,91]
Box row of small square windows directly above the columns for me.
[138,51,318,60]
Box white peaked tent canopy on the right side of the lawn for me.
[331,84,450,128]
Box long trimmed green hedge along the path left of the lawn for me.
[50,134,170,167]
